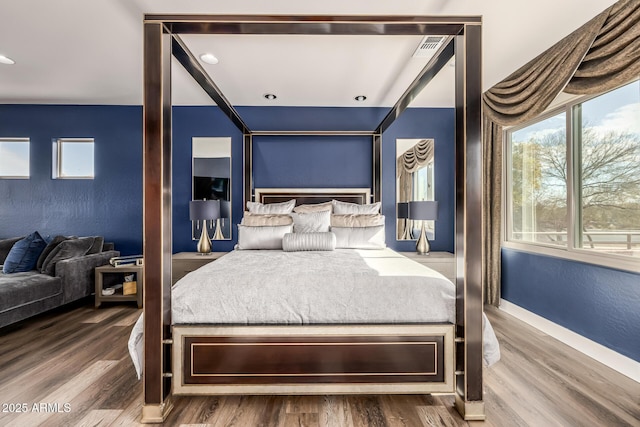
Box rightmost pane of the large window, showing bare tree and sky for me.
[573,82,640,257]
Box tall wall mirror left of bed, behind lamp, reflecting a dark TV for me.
[191,137,232,240]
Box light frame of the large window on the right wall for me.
[500,79,640,272]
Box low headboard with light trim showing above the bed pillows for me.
[254,188,371,205]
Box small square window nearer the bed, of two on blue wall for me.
[53,139,95,179]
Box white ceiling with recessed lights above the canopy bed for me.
[0,0,615,107]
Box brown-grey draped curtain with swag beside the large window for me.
[482,0,640,306]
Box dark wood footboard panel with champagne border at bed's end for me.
[172,324,455,395]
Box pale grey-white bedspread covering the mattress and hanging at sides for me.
[129,249,500,376]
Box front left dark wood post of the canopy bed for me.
[141,21,172,423]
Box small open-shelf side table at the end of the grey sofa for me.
[95,265,144,308]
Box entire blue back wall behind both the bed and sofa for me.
[0,105,454,254]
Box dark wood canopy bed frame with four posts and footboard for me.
[142,15,484,423]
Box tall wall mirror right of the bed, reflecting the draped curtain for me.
[396,138,436,240]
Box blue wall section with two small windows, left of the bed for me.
[0,105,142,254]
